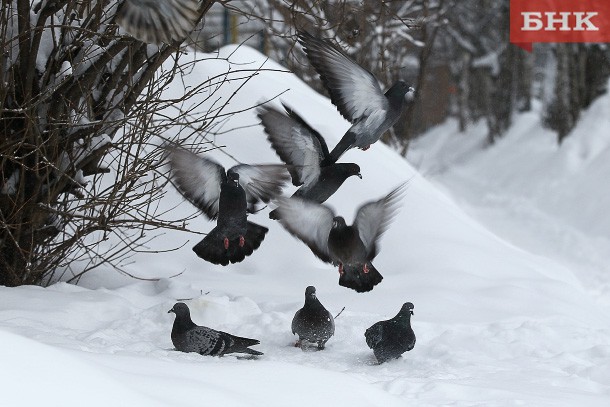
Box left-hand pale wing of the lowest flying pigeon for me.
[277,197,335,263]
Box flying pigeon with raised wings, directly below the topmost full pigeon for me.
[258,105,362,219]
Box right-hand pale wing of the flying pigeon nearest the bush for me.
[229,164,290,203]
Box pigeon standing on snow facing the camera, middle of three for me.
[292,286,335,349]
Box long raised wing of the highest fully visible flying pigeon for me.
[298,32,389,123]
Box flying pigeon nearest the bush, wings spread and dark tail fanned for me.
[168,148,290,266]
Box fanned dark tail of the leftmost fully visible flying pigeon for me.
[193,222,269,266]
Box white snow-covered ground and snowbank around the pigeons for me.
[0,47,610,406]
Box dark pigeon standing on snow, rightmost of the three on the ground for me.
[364,302,415,363]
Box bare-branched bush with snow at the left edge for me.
[0,0,213,286]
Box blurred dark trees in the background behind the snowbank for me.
[202,0,610,147]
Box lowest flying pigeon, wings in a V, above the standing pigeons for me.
[276,184,405,292]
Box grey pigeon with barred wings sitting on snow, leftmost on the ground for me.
[167,302,263,356]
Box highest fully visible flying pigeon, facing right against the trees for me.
[298,31,413,162]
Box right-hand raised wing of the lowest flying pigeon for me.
[354,184,406,261]
